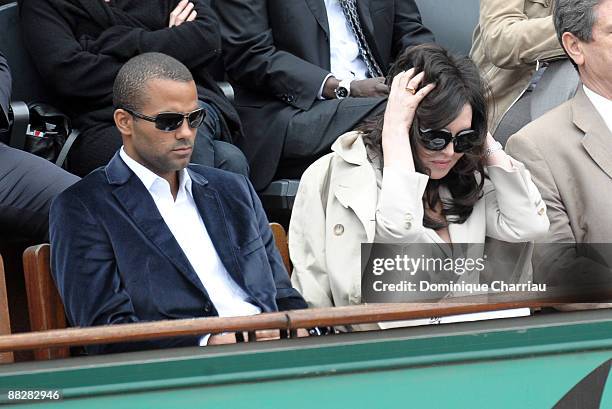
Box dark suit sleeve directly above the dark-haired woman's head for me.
[393,0,435,56]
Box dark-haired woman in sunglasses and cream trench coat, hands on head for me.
[289,45,549,307]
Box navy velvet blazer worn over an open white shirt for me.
[50,154,306,353]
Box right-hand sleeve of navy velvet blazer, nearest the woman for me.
[245,178,308,311]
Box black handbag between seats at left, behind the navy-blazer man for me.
[10,102,79,167]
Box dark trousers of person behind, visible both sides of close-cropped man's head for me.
[69,101,249,176]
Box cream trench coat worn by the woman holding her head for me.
[289,132,549,307]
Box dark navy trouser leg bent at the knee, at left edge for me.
[0,144,79,241]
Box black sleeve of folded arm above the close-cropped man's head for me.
[75,0,221,69]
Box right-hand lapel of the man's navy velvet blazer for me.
[188,169,246,290]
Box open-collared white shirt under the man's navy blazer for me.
[119,147,261,324]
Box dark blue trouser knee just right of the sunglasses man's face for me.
[191,101,249,176]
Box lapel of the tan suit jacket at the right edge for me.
[572,87,612,178]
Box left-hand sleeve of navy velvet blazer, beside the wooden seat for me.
[49,190,200,354]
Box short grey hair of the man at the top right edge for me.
[553,0,599,44]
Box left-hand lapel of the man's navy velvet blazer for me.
[106,154,206,294]
